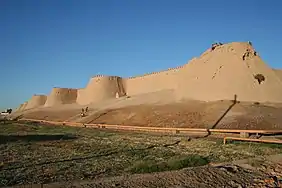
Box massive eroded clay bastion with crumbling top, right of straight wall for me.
[176,42,282,102]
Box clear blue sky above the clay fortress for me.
[0,0,282,108]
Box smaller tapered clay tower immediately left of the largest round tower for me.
[44,87,77,107]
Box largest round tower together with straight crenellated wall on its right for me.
[76,66,186,105]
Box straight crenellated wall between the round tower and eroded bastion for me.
[124,65,184,96]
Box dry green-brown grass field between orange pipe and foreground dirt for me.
[0,123,282,186]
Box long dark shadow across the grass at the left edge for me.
[0,134,77,144]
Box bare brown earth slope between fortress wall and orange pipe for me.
[20,101,282,129]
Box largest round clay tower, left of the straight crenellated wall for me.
[77,75,125,105]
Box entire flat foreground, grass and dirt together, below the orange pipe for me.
[0,122,282,188]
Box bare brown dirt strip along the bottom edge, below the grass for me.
[41,161,282,188]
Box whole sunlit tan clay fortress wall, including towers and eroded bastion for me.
[17,42,282,109]
